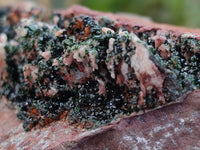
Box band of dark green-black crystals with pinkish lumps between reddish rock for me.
[0,6,200,130]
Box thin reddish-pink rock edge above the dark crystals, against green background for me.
[54,5,200,36]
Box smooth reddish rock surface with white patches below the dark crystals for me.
[0,90,200,150]
